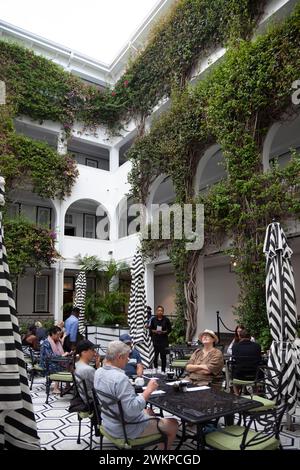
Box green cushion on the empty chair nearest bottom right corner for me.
[205,425,279,450]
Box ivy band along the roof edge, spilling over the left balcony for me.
[0,0,264,280]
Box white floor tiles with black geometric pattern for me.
[32,377,300,450]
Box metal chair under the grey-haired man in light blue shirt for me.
[92,389,168,450]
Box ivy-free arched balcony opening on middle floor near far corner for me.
[64,199,110,240]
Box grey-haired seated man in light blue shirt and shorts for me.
[94,341,178,449]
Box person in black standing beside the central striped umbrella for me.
[150,305,172,373]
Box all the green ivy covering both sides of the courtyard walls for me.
[0,0,300,342]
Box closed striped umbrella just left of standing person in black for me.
[128,250,154,367]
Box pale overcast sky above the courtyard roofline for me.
[0,0,158,64]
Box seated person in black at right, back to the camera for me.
[232,329,261,395]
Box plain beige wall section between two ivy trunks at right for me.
[203,265,239,332]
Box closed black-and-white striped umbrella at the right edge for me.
[264,222,300,413]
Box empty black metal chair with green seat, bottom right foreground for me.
[205,403,288,450]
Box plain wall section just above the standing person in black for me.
[153,274,175,315]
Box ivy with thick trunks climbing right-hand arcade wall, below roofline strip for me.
[130,6,300,337]
